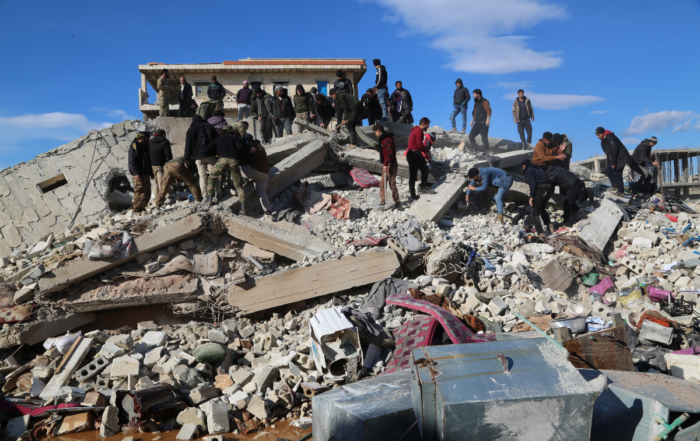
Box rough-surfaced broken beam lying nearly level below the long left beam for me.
[64,274,200,312]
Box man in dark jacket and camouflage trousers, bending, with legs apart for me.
[204,121,254,209]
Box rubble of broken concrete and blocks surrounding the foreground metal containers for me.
[0,118,700,440]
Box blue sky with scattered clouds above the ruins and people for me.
[0,0,700,169]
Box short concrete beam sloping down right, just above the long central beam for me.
[222,215,333,261]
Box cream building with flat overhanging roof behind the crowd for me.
[139,58,367,120]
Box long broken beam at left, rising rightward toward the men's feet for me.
[39,215,206,294]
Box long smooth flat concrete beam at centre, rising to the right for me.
[228,250,400,314]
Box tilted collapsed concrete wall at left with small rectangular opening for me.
[0,120,153,257]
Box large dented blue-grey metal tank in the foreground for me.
[412,339,604,441]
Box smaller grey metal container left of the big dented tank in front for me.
[312,370,421,441]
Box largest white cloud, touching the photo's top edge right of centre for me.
[372,0,567,74]
